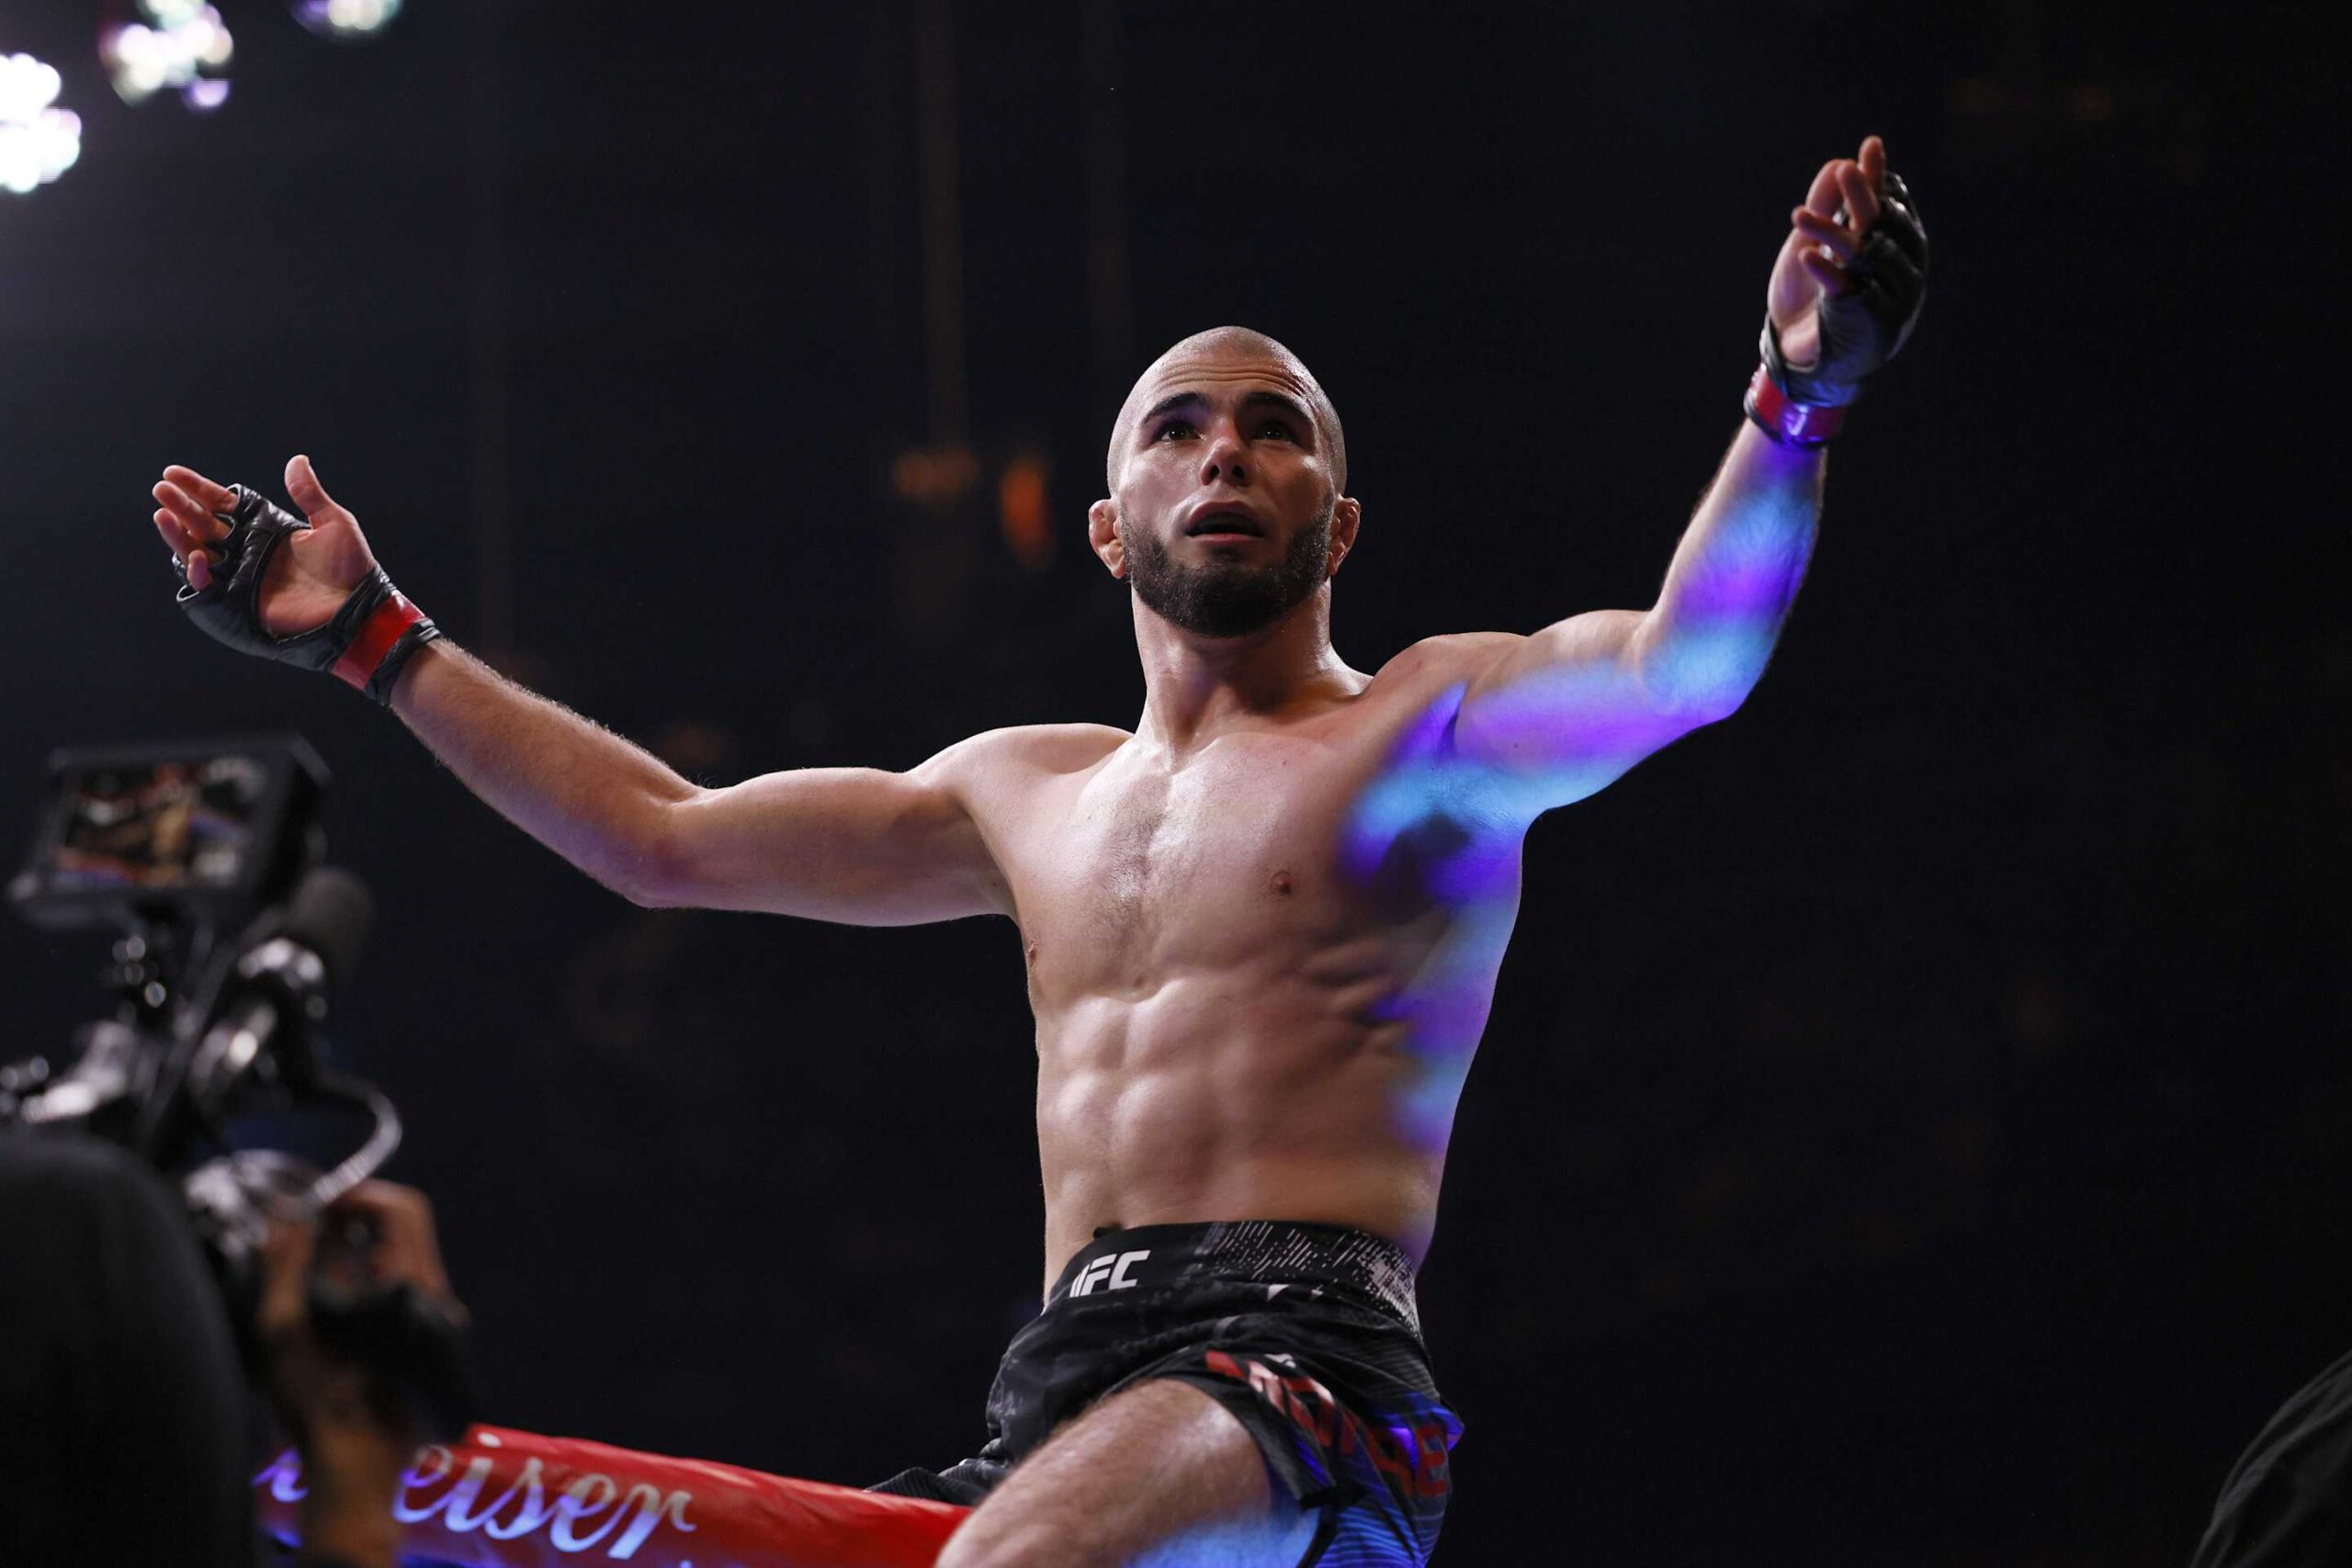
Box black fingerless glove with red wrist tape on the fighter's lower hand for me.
[179,484,440,705]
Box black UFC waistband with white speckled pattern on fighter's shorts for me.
[1046,1220,1420,1333]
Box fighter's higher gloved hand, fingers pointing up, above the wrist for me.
[1764,136,1927,383]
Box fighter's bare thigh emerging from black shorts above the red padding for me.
[938,1382,1317,1568]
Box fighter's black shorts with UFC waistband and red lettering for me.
[873,1220,1461,1568]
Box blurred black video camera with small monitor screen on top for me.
[0,739,475,1441]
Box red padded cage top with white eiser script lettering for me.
[254,1427,969,1568]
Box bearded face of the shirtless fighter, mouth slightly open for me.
[1113,350,1352,637]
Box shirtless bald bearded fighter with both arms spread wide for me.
[155,136,1927,1568]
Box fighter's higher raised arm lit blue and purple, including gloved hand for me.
[1453,136,1927,804]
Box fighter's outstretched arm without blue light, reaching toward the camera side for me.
[155,458,1009,926]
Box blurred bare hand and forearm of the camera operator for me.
[259,1182,463,1568]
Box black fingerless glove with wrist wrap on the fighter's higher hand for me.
[1747,169,1927,446]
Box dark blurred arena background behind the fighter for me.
[0,0,2352,1568]
